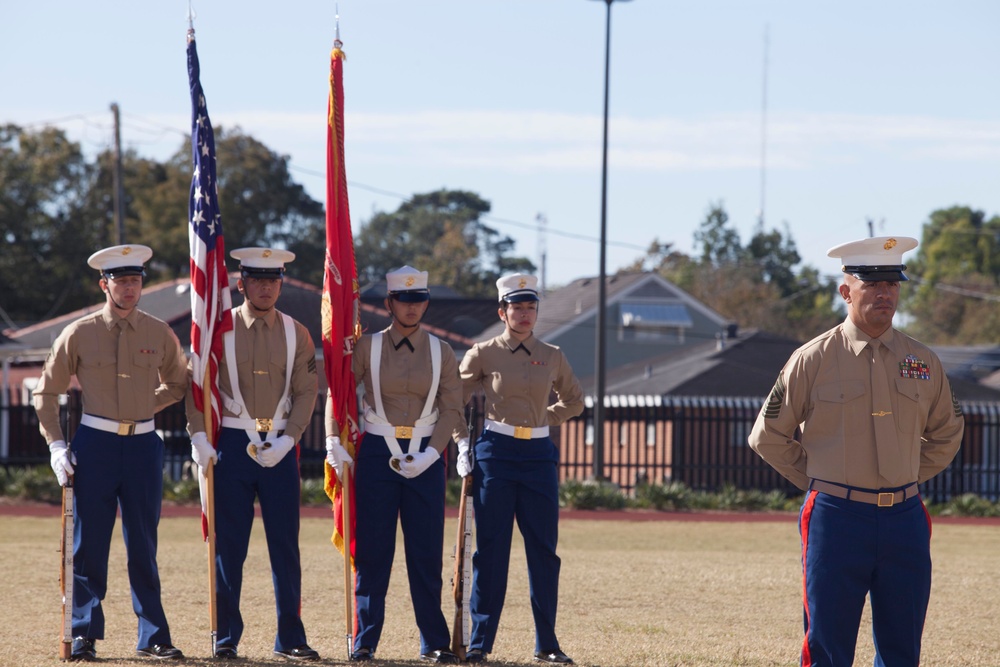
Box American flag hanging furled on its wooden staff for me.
[187,30,233,500]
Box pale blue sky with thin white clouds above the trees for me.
[0,0,1000,287]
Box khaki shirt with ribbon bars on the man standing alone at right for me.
[749,319,965,489]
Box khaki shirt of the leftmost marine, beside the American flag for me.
[34,303,187,443]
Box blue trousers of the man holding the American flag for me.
[215,428,306,651]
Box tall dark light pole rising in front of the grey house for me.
[594,0,629,480]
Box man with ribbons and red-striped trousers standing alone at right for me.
[749,237,965,667]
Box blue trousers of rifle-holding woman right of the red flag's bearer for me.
[469,431,561,653]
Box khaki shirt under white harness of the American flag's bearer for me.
[185,302,319,442]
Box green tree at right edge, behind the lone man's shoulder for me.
[902,206,1000,345]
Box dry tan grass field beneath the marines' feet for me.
[0,516,1000,667]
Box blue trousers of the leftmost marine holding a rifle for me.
[71,426,171,648]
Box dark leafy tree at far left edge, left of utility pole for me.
[0,125,103,324]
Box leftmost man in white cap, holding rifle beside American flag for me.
[34,245,187,661]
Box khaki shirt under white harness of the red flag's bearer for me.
[326,325,468,453]
